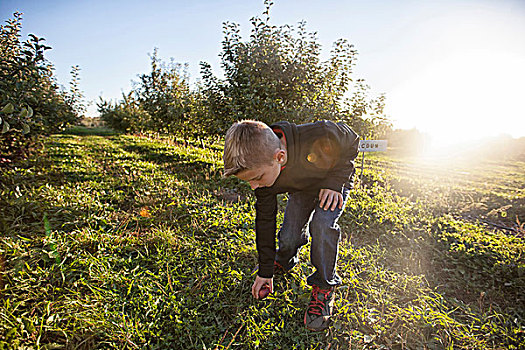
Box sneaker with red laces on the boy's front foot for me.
[304,285,335,331]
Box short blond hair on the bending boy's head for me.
[223,120,281,176]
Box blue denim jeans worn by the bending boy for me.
[275,188,349,288]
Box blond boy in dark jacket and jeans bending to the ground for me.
[223,120,359,330]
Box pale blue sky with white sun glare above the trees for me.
[0,0,525,144]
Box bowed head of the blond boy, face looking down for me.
[223,120,286,189]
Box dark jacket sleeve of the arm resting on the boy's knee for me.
[316,122,359,192]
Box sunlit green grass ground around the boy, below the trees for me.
[0,130,525,349]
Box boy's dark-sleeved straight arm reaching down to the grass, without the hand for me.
[255,189,277,278]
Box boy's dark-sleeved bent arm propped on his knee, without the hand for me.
[320,123,359,192]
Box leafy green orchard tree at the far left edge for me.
[0,12,78,160]
